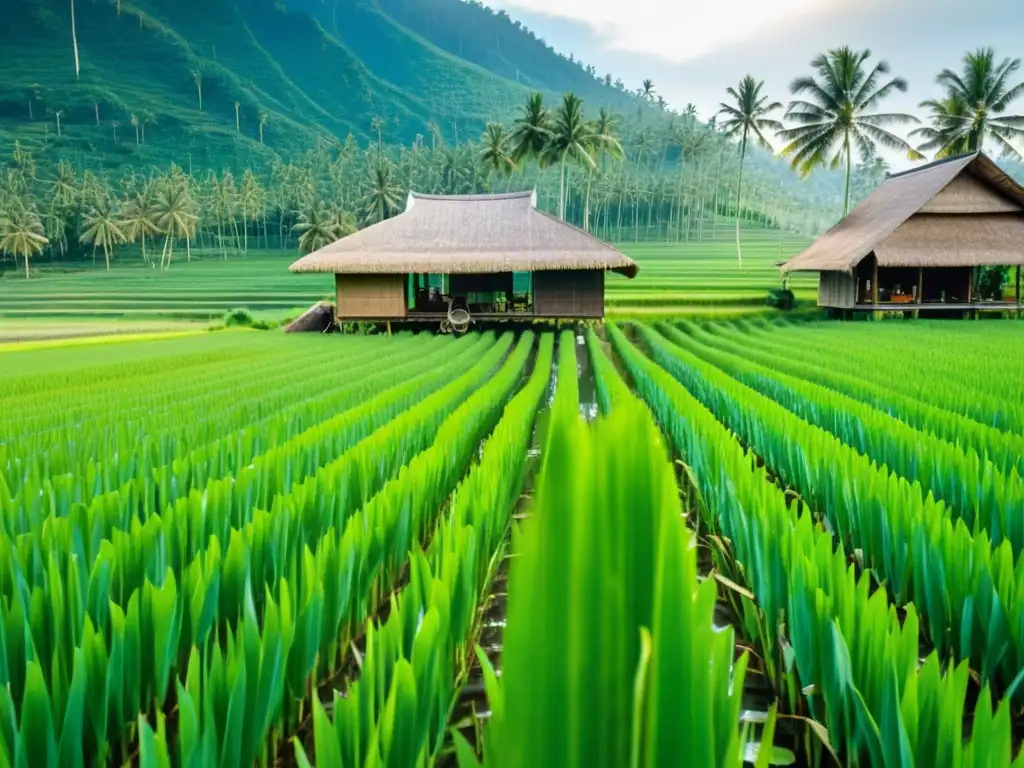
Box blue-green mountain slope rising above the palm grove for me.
[0,0,629,173]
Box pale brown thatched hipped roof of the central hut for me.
[291,191,637,278]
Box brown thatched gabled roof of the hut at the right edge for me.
[782,153,1024,272]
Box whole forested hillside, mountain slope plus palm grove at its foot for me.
[0,0,860,278]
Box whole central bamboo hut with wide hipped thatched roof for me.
[291,191,637,330]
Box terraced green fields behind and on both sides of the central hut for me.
[0,229,816,322]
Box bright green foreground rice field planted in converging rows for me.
[0,318,1024,768]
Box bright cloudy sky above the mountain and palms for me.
[487,0,1024,166]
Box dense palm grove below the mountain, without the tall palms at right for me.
[0,93,814,271]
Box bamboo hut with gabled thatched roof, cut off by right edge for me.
[782,153,1024,316]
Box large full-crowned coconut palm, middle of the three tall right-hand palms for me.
[779,46,923,215]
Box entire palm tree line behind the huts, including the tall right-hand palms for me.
[0,47,1024,275]
